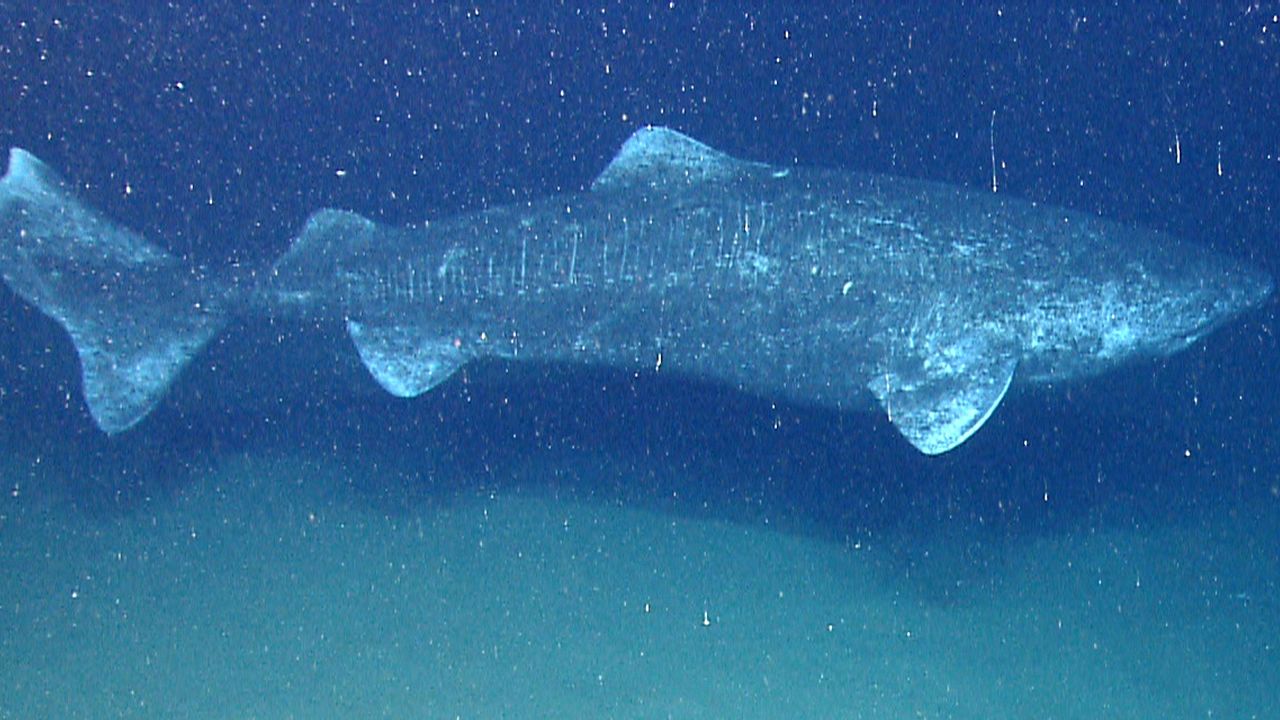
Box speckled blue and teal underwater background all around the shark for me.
[0,1,1280,719]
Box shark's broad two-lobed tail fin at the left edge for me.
[0,149,227,433]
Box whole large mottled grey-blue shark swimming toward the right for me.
[0,127,1272,455]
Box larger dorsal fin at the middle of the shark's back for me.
[591,127,756,191]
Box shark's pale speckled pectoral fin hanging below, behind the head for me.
[867,342,1018,455]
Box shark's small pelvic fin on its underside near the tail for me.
[347,320,467,397]
